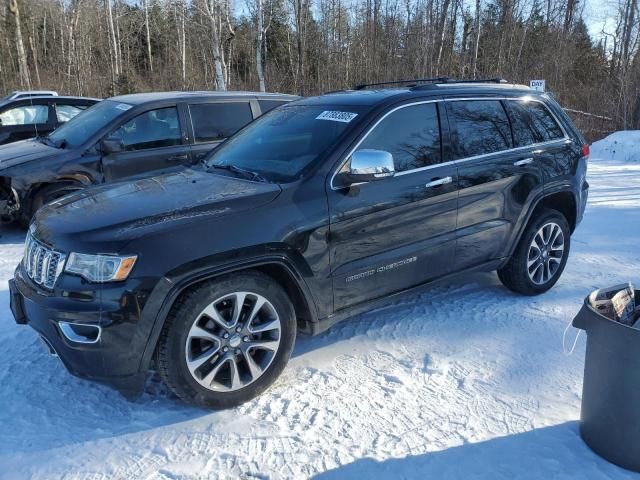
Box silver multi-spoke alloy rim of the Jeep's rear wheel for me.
[527,222,564,285]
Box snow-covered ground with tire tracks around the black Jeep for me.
[0,132,640,480]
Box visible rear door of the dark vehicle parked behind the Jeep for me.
[188,99,258,163]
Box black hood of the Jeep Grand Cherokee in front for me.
[32,169,281,248]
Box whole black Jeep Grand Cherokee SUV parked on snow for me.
[10,82,588,407]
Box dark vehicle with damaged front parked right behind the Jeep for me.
[0,92,299,223]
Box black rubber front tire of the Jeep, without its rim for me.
[156,271,296,409]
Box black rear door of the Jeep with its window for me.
[446,99,544,270]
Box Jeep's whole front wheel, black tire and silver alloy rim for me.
[157,272,296,408]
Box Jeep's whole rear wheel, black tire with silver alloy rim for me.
[498,208,571,295]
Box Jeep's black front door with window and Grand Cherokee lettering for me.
[328,102,458,310]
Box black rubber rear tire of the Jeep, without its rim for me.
[498,208,571,295]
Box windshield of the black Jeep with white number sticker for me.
[206,105,362,182]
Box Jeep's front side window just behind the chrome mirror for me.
[358,103,442,172]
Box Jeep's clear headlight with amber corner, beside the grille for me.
[64,253,138,283]
